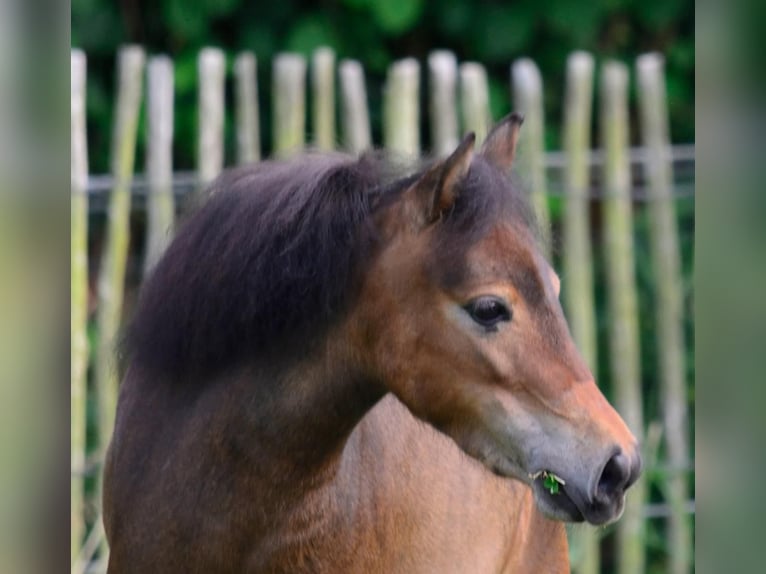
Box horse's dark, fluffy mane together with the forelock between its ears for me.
[121,154,531,379]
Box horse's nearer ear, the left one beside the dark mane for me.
[413,132,476,225]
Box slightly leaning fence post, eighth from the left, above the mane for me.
[338,60,372,154]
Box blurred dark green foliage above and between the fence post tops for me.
[72,0,694,172]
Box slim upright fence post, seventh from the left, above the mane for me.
[311,48,335,150]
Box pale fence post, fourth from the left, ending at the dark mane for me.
[197,48,226,188]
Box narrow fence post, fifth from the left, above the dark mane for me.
[234,52,261,165]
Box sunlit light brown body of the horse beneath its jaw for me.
[340,395,568,572]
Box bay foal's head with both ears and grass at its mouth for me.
[351,114,641,524]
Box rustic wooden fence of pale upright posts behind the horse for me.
[71,46,693,574]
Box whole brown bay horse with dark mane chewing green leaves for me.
[103,114,641,574]
